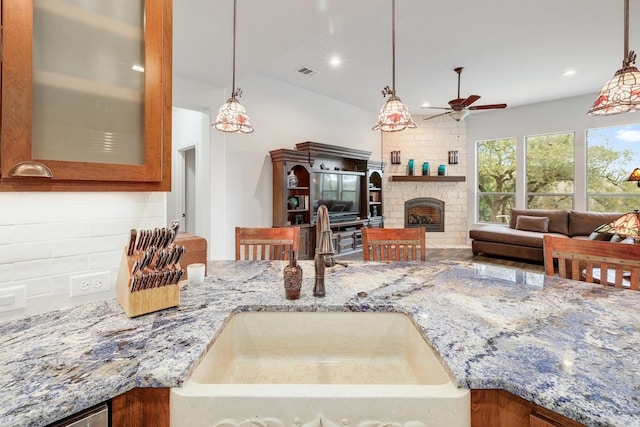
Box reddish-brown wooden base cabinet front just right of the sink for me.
[471,390,584,427]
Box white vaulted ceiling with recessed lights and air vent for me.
[174,0,640,115]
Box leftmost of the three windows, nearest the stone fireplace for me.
[476,138,516,223]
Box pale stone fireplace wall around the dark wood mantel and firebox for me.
[382,116,469,248]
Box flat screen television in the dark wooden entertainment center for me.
[311,172,363,222]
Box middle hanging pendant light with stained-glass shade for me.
[373,0,416,132]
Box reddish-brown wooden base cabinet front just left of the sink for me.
[111,387,171,427]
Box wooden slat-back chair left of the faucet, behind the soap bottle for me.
[236,227,300,260]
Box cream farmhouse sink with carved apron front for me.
[171,312,470,427]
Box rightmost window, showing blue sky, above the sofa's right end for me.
[586,124,640,212]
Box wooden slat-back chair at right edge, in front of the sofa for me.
[544,235,640,291]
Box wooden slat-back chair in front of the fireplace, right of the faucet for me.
[362,227,426,261]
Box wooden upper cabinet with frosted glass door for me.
[0,0,172,191]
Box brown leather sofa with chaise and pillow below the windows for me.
[469,209,623,262]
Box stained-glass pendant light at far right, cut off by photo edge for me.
[587,0,640,116]
